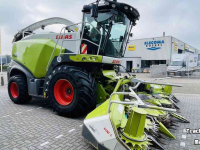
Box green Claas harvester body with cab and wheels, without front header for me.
[8,1,140,117]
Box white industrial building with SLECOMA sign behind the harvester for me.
[122,36,200,71]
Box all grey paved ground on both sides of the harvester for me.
[0,72,200,150]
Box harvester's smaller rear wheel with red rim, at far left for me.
[8,75,31,104]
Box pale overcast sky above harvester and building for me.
[0,0,200,54]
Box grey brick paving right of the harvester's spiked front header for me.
[164,94,200,150]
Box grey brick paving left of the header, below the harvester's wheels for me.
[0,87,93,150]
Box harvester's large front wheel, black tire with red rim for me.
[48,65,96,117]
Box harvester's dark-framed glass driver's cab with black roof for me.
[81,1,139,58]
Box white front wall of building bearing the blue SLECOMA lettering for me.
[125,36,171,60]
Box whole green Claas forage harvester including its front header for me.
[7,0,187,150]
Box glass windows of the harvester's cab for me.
[82,12,130,57]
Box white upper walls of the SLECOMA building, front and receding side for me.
[125,36,200,63]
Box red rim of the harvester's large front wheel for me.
[54,79,74,106]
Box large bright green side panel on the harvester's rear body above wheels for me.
[12,39,61,78]
